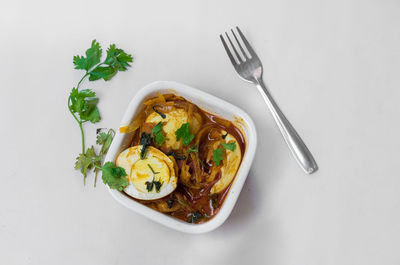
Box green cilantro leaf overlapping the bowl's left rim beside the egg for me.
[101,162,129,191]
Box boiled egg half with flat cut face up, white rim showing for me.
[115,145,178,200]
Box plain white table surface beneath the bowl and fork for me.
[0,0,400,265]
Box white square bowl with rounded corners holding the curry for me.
[105,81,257,234]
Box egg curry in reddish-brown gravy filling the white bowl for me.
[115,93,245,223]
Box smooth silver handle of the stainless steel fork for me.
[256,80,318,174]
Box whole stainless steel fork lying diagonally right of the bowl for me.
[219,27,318,174]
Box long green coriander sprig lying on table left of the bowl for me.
[68,40,133,184]
